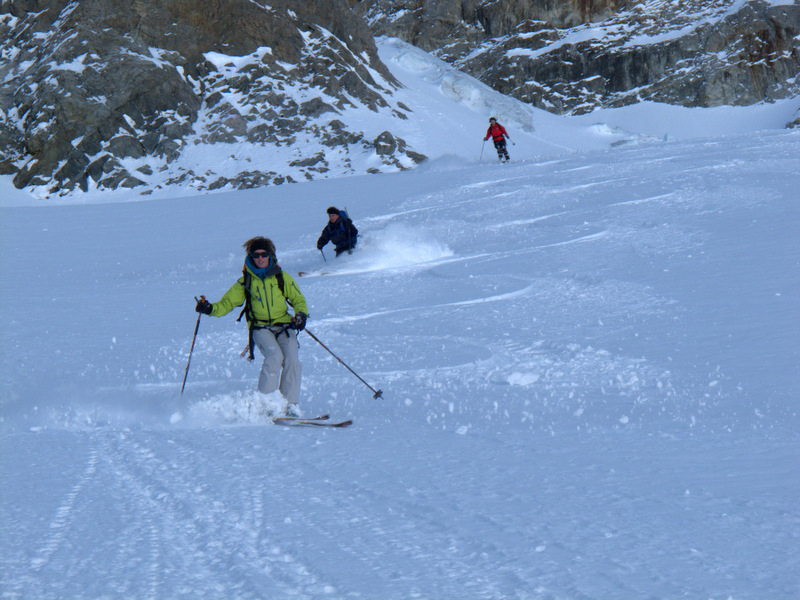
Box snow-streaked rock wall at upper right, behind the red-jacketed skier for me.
[351,0,800,113]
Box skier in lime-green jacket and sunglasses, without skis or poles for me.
[195,236,308,416]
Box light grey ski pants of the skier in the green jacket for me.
[253,327,302,404]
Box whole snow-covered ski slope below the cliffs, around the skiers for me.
[0,40,800,600]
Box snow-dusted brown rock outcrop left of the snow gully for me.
[0,0,421,192]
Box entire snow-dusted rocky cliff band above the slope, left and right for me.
[0,0,800,195]
